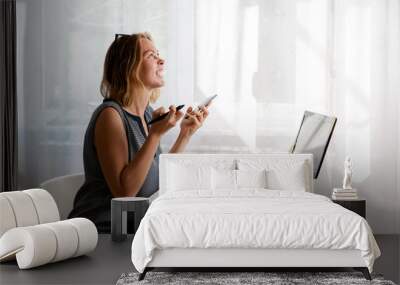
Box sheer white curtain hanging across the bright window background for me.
[17,0,400,233]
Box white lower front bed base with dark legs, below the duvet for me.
[139,248,371,280]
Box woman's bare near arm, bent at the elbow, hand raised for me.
[94,107,182,197]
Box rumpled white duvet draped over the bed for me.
[132,189,380,272]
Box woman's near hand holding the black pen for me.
[149,105,183,137]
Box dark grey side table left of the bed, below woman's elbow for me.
[111,197,149,241]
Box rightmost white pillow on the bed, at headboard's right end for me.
[267,162,309,191]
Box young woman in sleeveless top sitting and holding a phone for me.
[69,33,208,232]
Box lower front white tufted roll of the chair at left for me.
[0,218,97,269]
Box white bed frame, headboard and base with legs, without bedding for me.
[139,154,371,280]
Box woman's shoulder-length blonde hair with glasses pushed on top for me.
[100,33,160,106]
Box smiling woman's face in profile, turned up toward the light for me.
[140,38,164,89]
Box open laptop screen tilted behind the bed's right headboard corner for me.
[292,111,337,179]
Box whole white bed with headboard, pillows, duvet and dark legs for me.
[132,154,380,278]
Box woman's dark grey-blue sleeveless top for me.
[68,100,161,233]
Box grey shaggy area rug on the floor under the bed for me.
[117,272,395,285]
